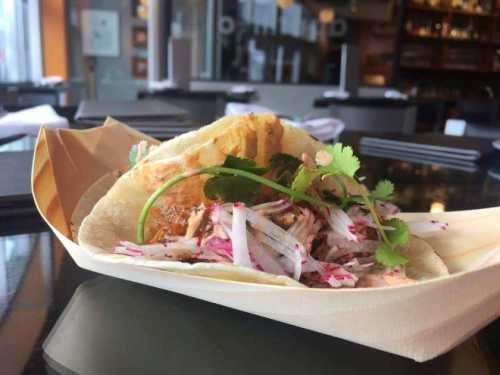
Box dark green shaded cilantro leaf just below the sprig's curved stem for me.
[203,176,260,204]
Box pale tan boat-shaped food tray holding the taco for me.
[32,120,500,361]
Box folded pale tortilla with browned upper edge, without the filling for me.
[79,114,447,286]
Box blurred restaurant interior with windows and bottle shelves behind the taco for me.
[0,0,500,138]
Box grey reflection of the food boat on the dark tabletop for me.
[44,277,498,374]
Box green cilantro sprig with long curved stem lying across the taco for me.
[137,143,409,267]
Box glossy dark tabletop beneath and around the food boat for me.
[0,134,500,375]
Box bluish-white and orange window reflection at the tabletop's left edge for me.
[0,232,62,374]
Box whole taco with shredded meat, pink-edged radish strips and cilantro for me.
[79,114,448,288]
